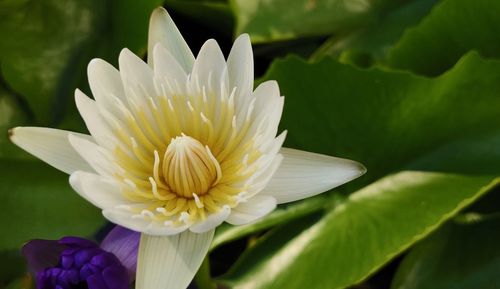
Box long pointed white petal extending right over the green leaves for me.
[261,148,366,204]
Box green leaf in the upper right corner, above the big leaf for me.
[387,0,500,75]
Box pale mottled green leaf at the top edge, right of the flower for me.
[231,0,395,43]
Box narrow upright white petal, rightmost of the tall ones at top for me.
[227,34,254,103]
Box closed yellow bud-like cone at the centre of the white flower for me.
[162,134,221,198]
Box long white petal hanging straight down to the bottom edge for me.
[135,230,214,289]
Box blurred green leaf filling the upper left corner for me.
[0,0,162,126]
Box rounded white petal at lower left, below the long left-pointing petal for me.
[69,171,129,209]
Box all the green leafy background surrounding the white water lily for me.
[0,0,500,289]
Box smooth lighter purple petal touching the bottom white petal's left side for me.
[101,226,141,280]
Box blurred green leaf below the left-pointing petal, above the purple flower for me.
[0,160,104,250]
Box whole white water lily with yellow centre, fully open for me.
[10,8,365,289]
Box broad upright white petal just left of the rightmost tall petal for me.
[191,39,229,94]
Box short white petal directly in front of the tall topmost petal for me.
[153,43,187,85]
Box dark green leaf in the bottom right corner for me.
[391,216,500,289]
